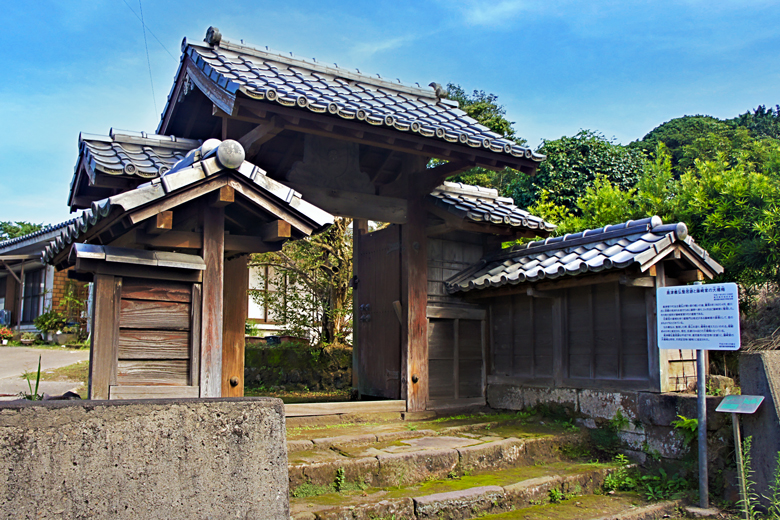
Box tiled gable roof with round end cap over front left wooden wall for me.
[42,139,333,263]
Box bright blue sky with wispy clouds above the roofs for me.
[0,0,780,223]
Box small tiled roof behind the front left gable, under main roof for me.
[79,128,201,179]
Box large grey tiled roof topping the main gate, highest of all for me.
[161,29,544,162]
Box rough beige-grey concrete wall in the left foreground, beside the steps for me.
[0,398,290,520]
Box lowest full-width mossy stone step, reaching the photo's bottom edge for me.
[290,463,614,520]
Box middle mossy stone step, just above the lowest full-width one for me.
[288,432,585,492]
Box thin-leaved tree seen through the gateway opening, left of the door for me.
[252,217,352,343]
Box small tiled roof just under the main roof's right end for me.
[430,181,555,232]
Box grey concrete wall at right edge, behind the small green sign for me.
[739,351,780,506]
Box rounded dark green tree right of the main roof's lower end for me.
[508,130,645,212]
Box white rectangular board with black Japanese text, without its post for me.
[656,283,739,350]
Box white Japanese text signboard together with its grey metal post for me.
[656,283,739,509]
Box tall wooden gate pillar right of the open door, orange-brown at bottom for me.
[401,189,428,412]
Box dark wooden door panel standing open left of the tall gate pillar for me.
[354,226,401,399]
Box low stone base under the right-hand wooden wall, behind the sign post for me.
[487,385,731,462]
